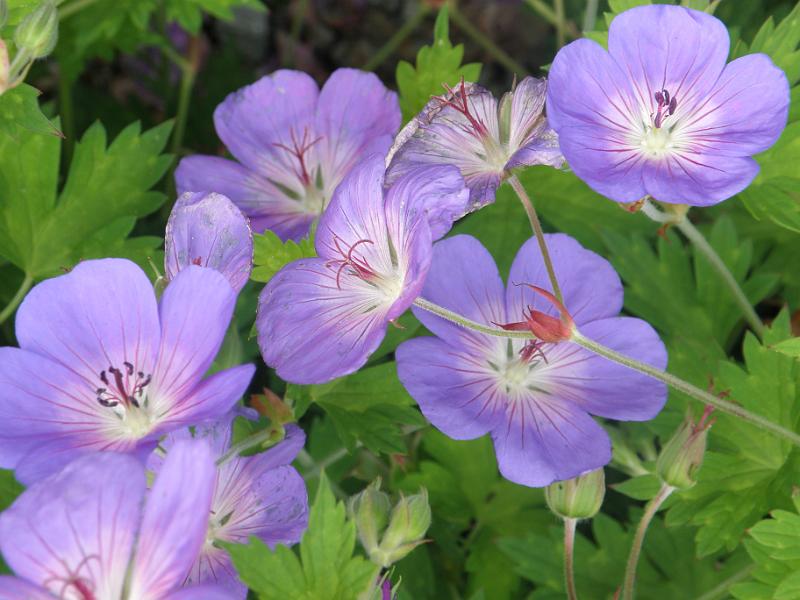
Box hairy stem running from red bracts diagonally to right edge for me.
[570,331,800,446]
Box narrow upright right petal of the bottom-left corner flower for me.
[129,441,216,598]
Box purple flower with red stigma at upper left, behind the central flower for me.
[175,69,400,239]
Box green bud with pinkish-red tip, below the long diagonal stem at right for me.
[656,406,714,490]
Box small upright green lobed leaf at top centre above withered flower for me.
[395,6,481,122]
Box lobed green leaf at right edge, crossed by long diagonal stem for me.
[668,312,800,556]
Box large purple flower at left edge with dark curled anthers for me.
[0,258,254,483]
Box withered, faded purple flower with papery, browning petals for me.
[386,77,564,210]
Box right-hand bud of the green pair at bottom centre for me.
[370,488,431,567]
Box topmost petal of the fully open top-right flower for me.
[608,5,730,116]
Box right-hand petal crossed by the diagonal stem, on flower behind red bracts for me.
[564,317,667,421]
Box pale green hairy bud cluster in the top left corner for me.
[0,0,58,94]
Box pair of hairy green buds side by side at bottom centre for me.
[348,478,431,568]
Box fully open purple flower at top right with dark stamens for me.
[547,5,789,206]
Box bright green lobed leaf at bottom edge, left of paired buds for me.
[225,474,378,600]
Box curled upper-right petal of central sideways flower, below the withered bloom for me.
[386,166,469,240]
